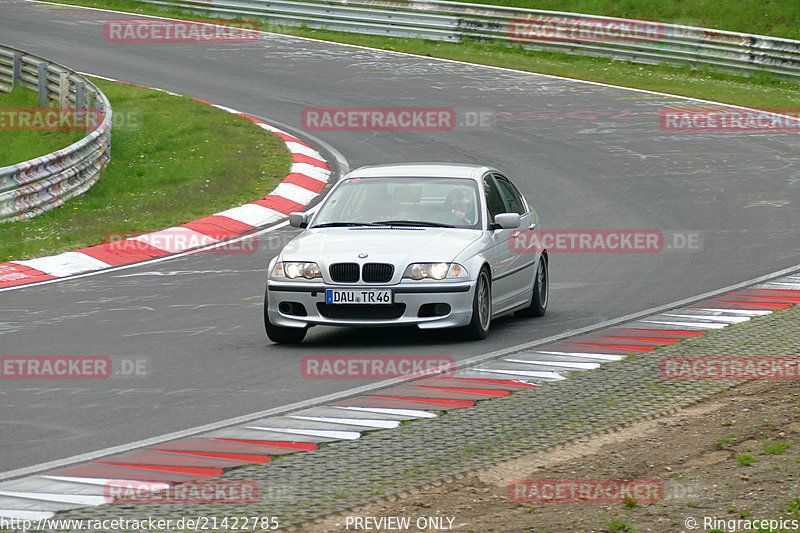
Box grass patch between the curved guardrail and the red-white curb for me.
[0,80,291,262]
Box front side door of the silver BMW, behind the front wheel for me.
[483,172,518,313]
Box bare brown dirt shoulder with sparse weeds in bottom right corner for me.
[302,381,800,533]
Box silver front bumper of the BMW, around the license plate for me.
[267,280,475,329]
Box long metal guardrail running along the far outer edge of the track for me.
[140,0,800,78]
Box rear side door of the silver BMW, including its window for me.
[494,173,538,305]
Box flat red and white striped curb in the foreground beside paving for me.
[0,274,800,520]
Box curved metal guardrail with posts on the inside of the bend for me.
[0,46,112,223]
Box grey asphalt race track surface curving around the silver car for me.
[0,0,800,472]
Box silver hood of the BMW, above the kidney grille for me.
[282,226,482,267]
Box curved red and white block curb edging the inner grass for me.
[0,87,331,289]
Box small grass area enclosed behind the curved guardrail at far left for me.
[0,87,86,167]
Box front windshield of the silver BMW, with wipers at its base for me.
[312,177,481,229]
